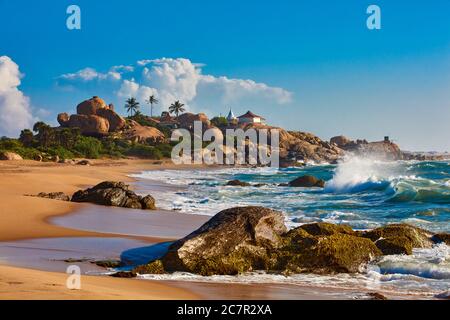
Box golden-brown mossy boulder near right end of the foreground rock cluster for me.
[362,224,434,254]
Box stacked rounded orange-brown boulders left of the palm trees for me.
[58,96,126,136]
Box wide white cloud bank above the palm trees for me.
[58,58,292,115]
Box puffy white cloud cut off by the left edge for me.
[0,56,35,136]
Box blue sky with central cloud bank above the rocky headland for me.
[0,0,450,151]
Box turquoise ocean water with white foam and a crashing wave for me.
[130,157,450,294]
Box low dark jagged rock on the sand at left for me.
[72,181,156,210]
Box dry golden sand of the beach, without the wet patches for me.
[0,160,205,299]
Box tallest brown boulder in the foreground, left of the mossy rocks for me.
[158,207,286,275]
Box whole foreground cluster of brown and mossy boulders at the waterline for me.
[132,207,449,275]
